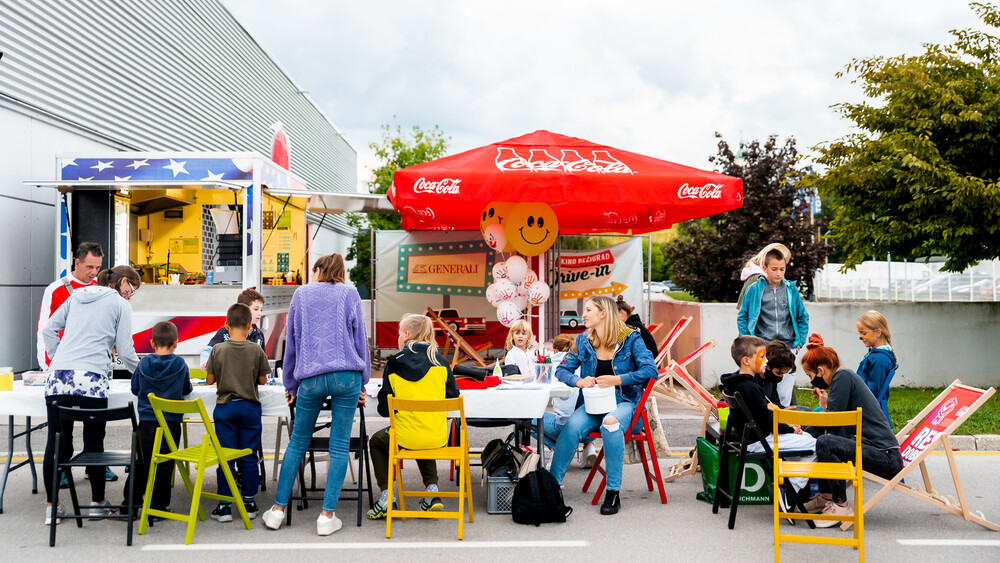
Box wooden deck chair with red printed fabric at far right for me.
[841,379,1000,531]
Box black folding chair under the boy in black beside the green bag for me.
[712,387,816,530]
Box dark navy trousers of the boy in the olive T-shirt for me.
[212,399,261,498]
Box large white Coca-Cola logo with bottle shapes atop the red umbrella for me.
[494,147,636,174]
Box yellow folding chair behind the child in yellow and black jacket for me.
[384,395,475,539]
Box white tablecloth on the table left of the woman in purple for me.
[0,379,288,418]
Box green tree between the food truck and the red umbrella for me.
[347,125,450,299]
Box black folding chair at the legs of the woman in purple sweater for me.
[285,401,375,526]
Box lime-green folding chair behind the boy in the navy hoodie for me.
[139,393,253,544]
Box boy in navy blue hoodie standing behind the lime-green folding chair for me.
[122,321,192,514]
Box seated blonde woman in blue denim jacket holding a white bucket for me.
[549,295,656,515]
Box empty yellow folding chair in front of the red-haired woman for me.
[772,408,865,563]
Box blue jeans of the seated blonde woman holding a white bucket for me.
[549,401,635,491]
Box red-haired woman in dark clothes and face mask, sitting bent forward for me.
[802,334,903,528]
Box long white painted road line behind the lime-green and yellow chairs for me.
[142,540,590,551]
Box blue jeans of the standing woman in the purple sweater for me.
[274,371,361,512]
